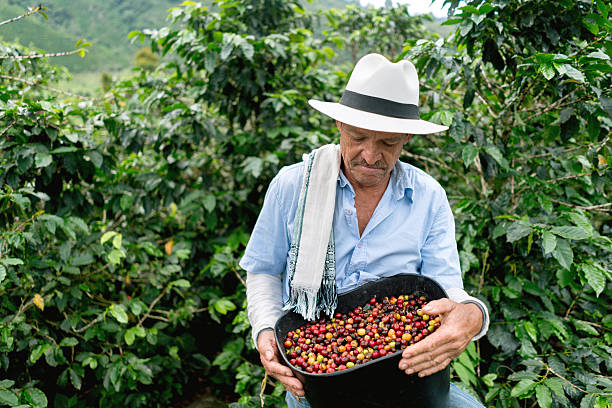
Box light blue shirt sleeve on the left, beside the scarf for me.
[239,178,289,275]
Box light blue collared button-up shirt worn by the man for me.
[240,161,463,302]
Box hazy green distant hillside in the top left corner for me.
[0,0,182,72]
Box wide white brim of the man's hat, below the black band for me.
[308,99,448,135]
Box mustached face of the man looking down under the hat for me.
[336,121,411,187]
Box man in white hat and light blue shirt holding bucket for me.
[240,54,488,407]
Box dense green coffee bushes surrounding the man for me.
[0,0,612,408]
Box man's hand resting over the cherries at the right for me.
[399,298,483,377]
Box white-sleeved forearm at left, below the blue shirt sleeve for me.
[246,273,283,347]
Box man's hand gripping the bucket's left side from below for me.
[257,326,306,397]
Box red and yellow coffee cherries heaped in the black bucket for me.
[283,295,440,374]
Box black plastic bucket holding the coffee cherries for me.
[275,274,450,408]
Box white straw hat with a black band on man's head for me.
[308,54,448,135]
